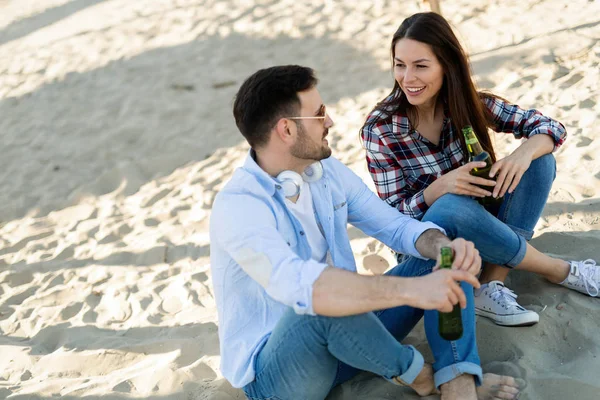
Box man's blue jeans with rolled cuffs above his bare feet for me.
[244,257,482,400]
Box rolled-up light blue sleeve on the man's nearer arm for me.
[211,195,327,315]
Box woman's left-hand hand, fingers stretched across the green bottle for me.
[434,161,496,197]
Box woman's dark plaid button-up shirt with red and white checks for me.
[361,98,567,219]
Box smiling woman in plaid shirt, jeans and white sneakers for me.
[361,13,600,326]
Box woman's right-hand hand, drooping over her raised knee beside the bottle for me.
[490,147,533,197]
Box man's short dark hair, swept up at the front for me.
[233,65,317,148]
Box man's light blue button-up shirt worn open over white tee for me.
[210,151,443,388]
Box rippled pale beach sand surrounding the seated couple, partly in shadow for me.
[0,0,600,400]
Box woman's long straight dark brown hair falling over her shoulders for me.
[374,12,497,162]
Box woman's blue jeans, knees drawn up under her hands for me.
[422,154,556,268]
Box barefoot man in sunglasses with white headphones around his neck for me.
[210,66,518,399]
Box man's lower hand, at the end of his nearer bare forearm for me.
[406,269,480,312]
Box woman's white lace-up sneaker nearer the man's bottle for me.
[475,281,540,326]
